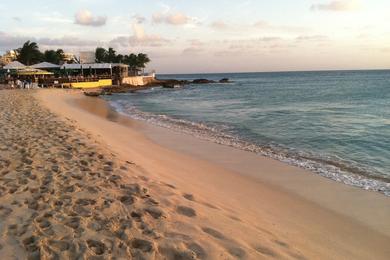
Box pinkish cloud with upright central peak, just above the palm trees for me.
[110,24,170,47]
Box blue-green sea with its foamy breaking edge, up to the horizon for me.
[105,71,390,196]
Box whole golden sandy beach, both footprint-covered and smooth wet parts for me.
[0,90,390,259]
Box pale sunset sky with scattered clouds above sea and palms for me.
[0,0,390,73]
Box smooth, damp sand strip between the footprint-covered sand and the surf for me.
[38,90,390,259]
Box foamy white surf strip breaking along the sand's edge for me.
[104,99,390,197]
